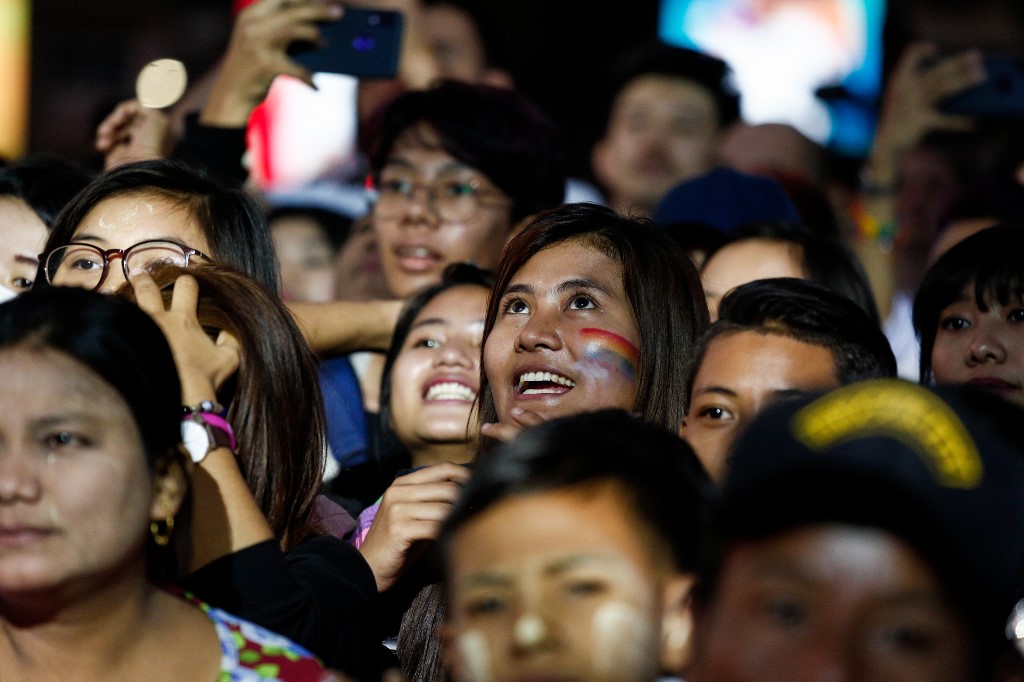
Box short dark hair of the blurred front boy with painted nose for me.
[438,410,714,572]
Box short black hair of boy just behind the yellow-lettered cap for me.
[686,278,896,405]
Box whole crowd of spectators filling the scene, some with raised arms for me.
[0,0,1024,682]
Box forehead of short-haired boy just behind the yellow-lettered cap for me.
[693,332,839,394]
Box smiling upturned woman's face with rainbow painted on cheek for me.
[483,240,641,423]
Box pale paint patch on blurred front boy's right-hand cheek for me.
[591,601,657,679]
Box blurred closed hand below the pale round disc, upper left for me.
[95,99,172,170]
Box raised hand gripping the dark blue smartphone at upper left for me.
[200,0,343,128]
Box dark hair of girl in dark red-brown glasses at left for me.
[36,159,278,293]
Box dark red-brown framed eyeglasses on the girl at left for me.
[39,240,211,291]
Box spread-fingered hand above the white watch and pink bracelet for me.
[129,270,240,404]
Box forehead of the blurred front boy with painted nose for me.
[450,484,664,581]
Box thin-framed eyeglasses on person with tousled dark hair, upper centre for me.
[373,177,512,222]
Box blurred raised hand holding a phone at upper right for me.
[870,43,986,184]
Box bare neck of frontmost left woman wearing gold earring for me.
[0,562,159,679]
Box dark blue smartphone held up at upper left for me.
[288,7,404,78]
